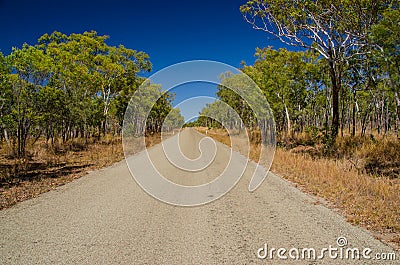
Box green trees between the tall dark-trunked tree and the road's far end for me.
[195,47,320,144]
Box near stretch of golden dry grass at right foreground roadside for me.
[272,149,400,246]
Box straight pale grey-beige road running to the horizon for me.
[0,129,400,264]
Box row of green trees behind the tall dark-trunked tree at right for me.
[197,39,399,147]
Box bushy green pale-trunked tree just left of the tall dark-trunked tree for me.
[243,47,317,140]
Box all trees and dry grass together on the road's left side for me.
[0,31,183,208]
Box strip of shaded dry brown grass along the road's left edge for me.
[0,135,161,209]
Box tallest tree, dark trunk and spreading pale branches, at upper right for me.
[240,0,391,138]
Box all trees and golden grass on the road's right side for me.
[188,0,400,246]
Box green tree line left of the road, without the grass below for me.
[0,31,182,157]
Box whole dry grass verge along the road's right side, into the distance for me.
[199,129,400,248]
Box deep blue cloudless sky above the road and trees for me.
[0,0,282,119]
